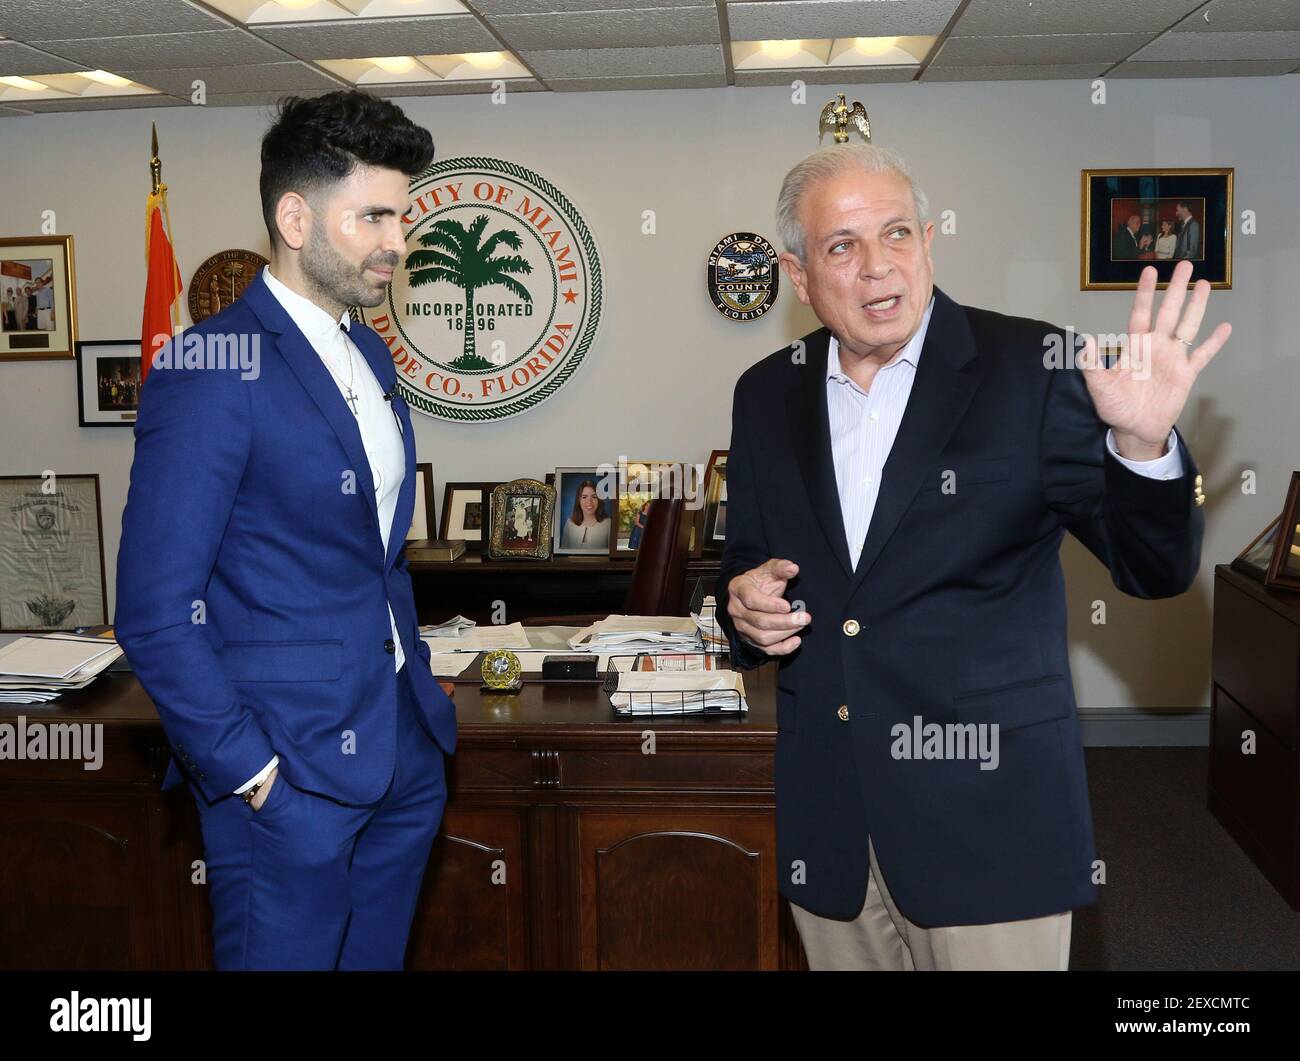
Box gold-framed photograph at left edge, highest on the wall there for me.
[0,235,77,361]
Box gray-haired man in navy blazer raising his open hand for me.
[718,146,1230,969]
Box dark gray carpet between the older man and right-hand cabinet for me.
[1070,748,1300,970]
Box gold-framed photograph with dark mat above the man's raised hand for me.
[1079,169,1234,291]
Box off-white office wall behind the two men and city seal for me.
[0,77,1300,709]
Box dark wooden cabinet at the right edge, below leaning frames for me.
[1209,566,1300,910]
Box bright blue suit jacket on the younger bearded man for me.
[116,274,456,804]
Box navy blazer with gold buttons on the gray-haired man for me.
[716,287,1204,926]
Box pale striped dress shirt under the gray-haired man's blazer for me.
[826,296,1183,568]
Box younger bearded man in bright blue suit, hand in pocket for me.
[116,91,456,969]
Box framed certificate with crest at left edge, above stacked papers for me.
[0,472,108,633]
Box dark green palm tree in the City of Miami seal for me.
[406,213,533,369]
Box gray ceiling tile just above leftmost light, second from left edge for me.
[36,30,285,70]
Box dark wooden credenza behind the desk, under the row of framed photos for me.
[407,553,720,624]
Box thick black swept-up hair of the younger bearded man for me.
[259,90,433,246]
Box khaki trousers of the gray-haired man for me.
[790,839,1071,971]
